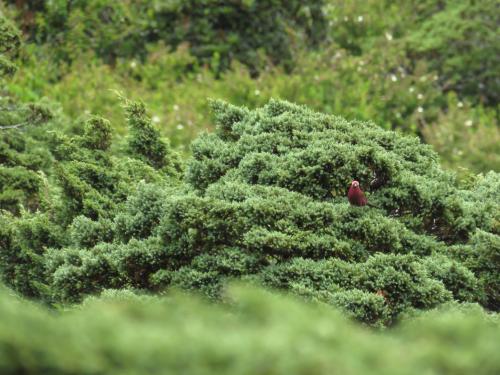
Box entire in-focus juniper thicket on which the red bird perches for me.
[0,100,500,326]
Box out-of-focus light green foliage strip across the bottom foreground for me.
[0,289,500,375]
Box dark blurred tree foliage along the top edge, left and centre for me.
[7,0,326,74]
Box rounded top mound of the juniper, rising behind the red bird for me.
[187,101,468,240]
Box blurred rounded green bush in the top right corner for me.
[409,0,500,106]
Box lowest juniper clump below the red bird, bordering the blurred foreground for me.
[262,254,458,324]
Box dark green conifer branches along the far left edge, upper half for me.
[0,12,53,214]
